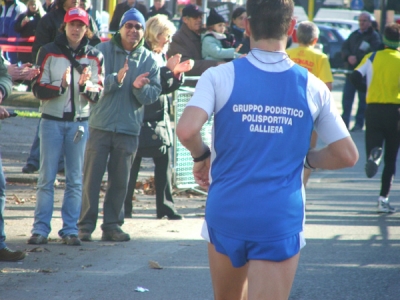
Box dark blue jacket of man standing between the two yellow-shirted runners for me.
[342,27,381,70]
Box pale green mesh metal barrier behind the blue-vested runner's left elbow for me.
[172,87,212,194]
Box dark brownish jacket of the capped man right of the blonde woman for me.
[168,23,218,76]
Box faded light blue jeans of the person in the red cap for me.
[32,119,88,237]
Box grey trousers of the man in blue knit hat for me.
[78,128,139,232]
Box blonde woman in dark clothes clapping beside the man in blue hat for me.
[125,15,193,220]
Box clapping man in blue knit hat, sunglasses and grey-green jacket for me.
[78,8,161,242]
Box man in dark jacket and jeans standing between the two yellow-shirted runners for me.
[342,12,381,132]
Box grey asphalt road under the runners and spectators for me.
[0,78,400,300]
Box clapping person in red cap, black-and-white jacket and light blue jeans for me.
[28,7,104,245]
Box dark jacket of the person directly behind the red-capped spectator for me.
[32,8,101,63]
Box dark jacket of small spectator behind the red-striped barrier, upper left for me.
[14,10,42,63]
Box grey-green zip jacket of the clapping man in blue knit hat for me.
[89,33,161,135]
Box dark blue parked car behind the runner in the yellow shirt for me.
[290,24,351,69]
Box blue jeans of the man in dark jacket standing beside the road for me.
[342,76,367,128]
